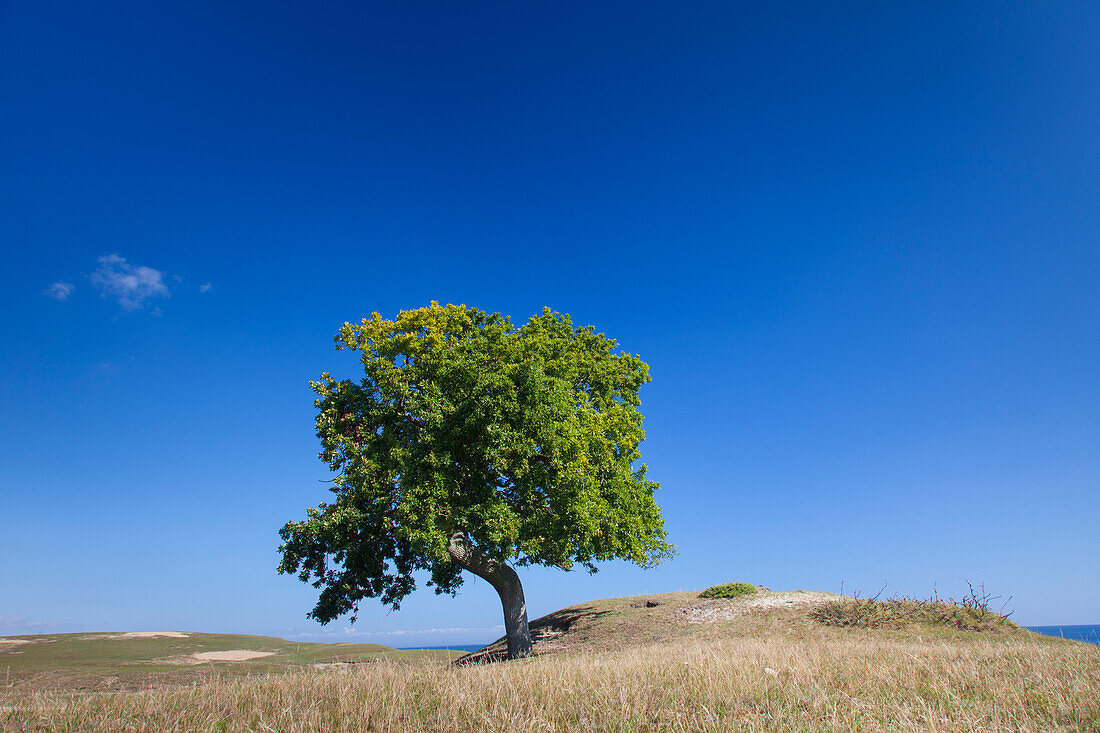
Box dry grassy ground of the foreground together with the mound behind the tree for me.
[0,592,1100,732]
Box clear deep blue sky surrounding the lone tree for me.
[0,0,1100,646]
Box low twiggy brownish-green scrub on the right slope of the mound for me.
[810,586,1016,632]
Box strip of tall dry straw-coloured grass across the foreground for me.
[0,630,1100,733]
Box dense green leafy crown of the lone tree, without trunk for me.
[278,303,672,623]
